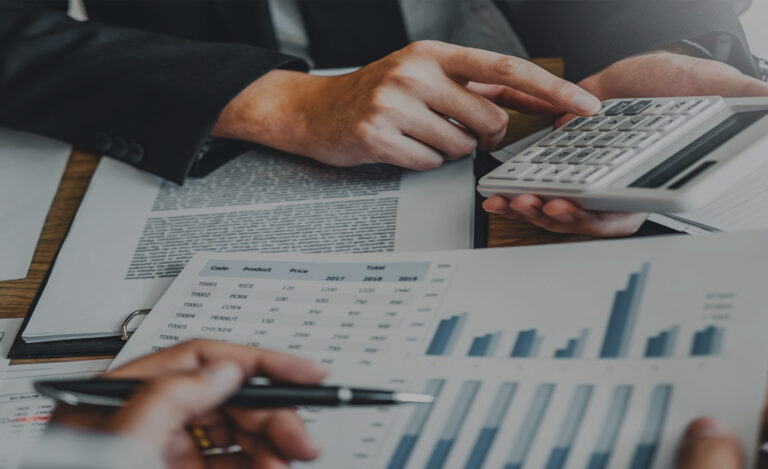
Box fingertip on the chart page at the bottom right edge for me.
[676,418,744,469]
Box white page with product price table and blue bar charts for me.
[115,232,768,469]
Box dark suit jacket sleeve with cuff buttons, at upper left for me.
[0,0,304,183]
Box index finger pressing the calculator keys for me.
[435,45,601,115]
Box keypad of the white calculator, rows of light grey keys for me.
[488,97,724,188]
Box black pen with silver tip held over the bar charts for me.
[35,379,434,408]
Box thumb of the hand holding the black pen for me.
[109,362,245,445]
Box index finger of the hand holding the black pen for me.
[105,339,327,384]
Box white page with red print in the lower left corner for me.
[0,360,110,469]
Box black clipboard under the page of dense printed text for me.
[8,152,492,359]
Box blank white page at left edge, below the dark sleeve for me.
[0,129,71,281]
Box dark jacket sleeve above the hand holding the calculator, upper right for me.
[496,0,756,81]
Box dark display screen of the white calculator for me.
[629,111,768,189]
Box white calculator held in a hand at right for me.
[478,96,768,213]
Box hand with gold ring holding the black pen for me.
[48,340,334,468]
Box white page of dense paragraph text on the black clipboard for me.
[24,150,474,341]
